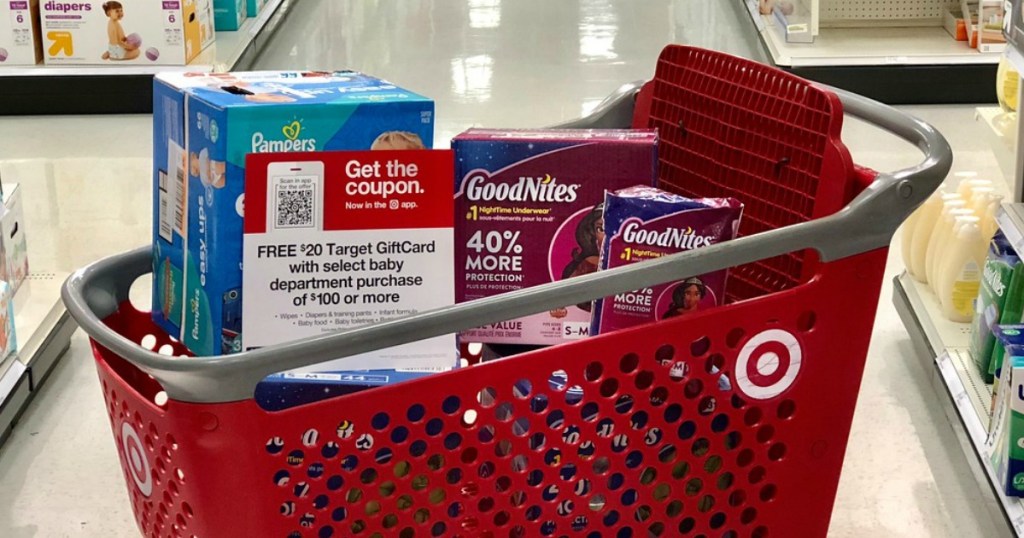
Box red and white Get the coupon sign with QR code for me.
[242,150,456,372]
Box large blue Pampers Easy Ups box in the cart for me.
[153,72,434,356]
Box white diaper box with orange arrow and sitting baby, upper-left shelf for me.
[41,0,214,66]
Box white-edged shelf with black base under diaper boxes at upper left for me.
[0,0,299,116]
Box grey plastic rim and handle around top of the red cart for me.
[61,83,952,403]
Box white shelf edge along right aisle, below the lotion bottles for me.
[893,274,1024,537]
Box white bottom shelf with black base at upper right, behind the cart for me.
[746,0,999,104]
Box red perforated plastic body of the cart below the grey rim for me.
[96,243,885,537]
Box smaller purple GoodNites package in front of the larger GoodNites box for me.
[591,187,743,334]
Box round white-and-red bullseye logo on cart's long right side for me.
[736,329,804,400]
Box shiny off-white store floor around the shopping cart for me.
[0,0,1001,538]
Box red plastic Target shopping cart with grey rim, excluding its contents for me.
[63,46,951,538]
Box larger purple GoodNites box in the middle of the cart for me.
[452,129,657,345]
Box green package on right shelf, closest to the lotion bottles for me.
[970,234,1024,383]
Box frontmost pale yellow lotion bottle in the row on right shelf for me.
[936,216,986,323]
